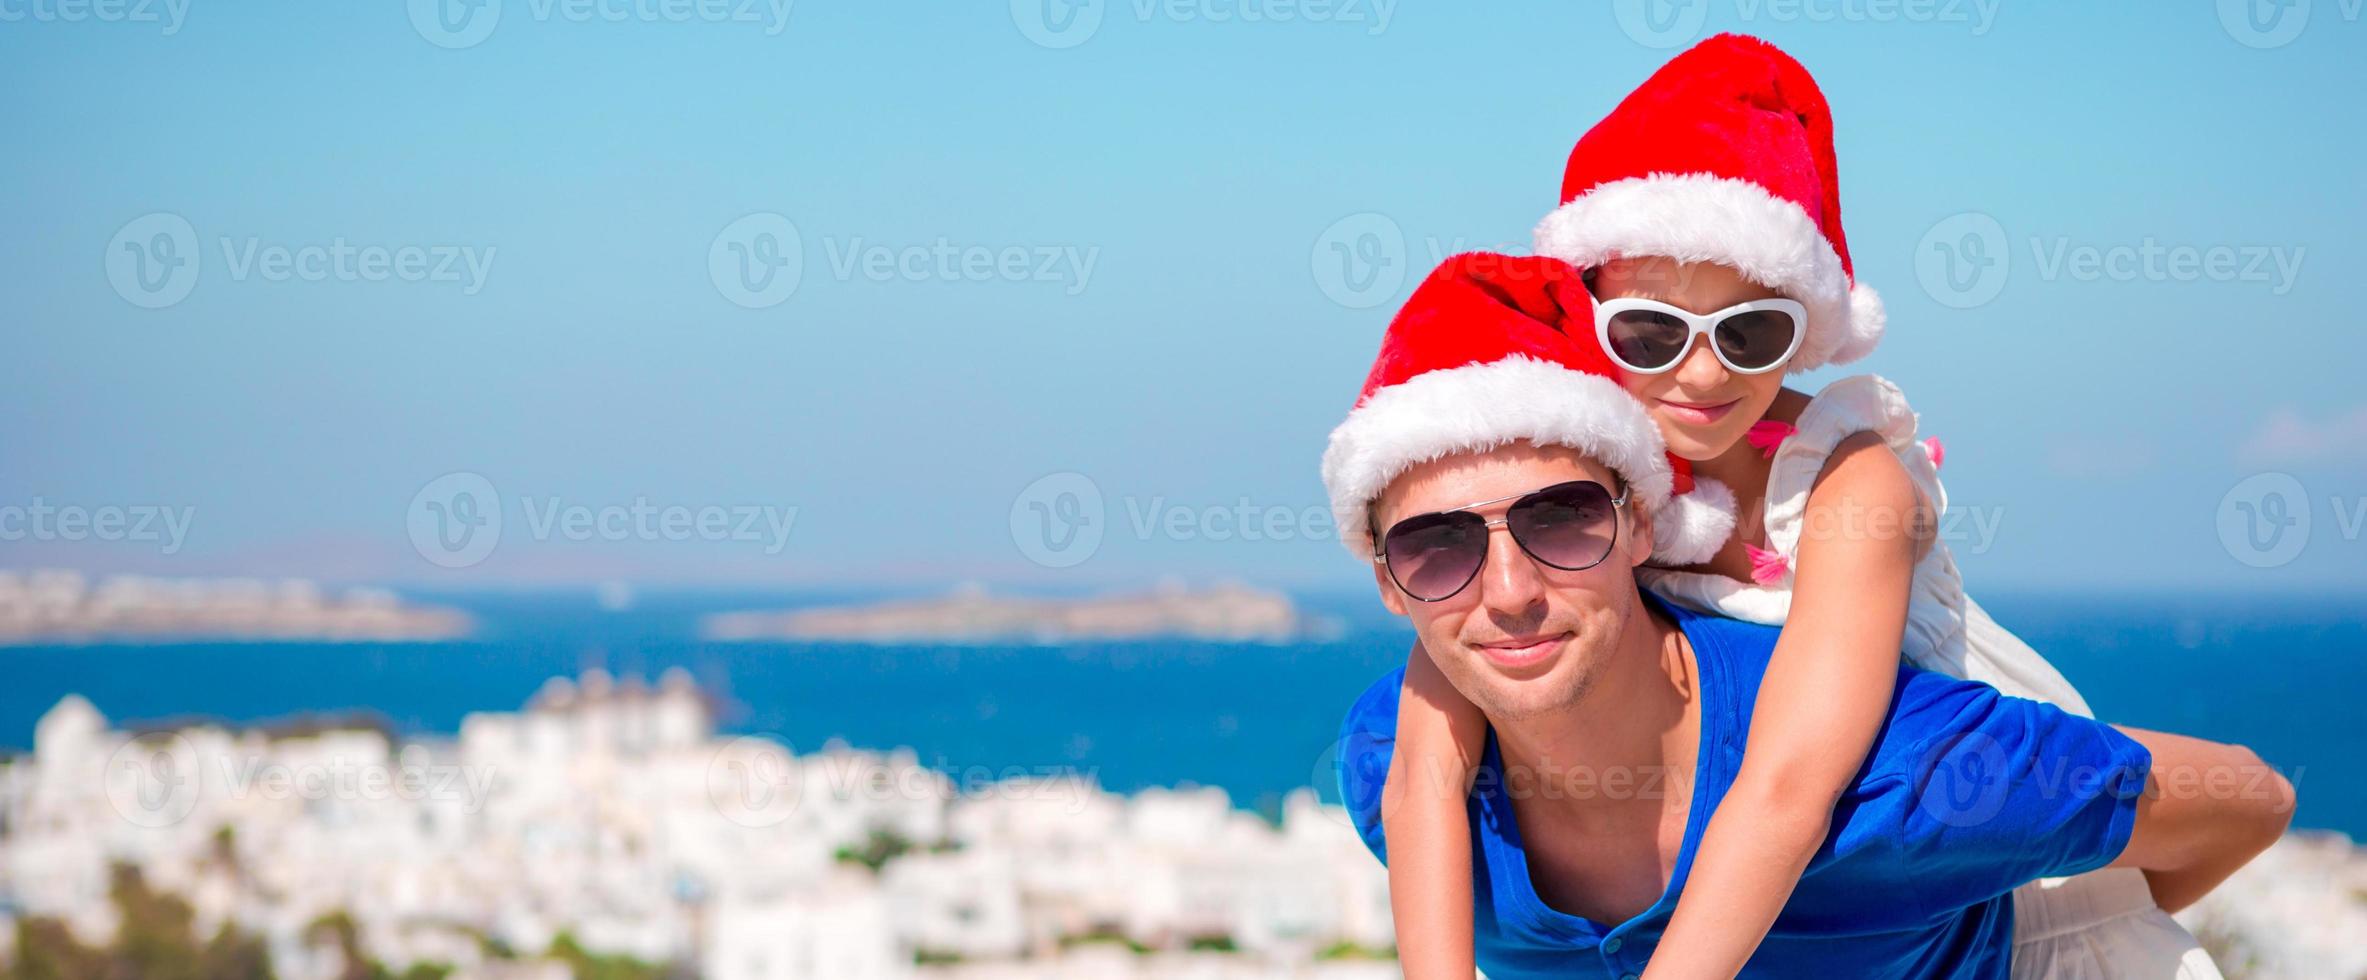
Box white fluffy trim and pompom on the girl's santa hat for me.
[1536,173,1882,372]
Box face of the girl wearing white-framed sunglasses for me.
[1593,256,1782,459]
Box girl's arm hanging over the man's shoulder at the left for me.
[1380,641,1486,980]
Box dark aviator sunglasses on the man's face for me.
[1373,481,1626,601]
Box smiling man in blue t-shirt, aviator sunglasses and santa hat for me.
[1323,256,2294,980]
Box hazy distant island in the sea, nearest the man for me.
[698,585,1307,644]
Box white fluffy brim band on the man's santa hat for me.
[1323,355,1671,559]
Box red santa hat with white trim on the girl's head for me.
[1536,33,1882,372]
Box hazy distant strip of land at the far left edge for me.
[0,570,476,646]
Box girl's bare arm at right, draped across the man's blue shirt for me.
[1645,433,1931,980]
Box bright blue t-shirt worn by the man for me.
[1340,594,2154,980]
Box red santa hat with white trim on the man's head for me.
[1323,253,1735,563]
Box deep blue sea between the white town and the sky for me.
[0,589,2367,838]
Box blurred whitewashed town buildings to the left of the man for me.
[0,670,1394,980]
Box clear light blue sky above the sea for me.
[0,0,2367,592]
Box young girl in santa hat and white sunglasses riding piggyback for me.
[1385,36,2218,980]
